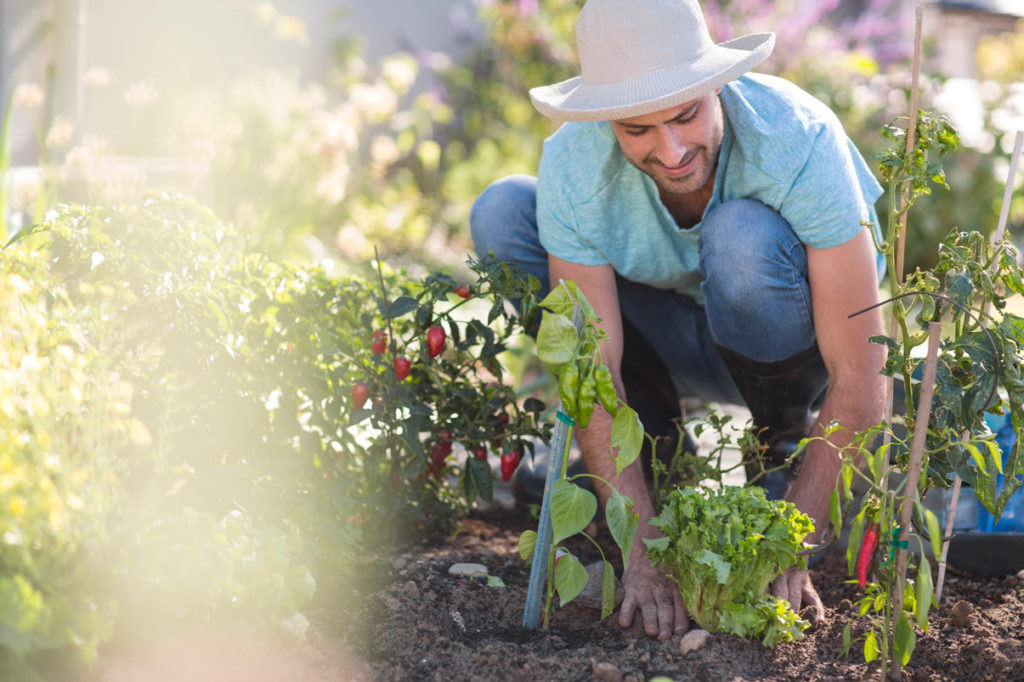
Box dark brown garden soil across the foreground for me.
[313,501,1024,680]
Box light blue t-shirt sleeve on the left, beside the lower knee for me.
[537,151,608,265]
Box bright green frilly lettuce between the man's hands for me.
[644,486,814,647]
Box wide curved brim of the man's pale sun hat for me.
[529,33,775,121]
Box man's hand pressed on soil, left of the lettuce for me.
[618,555,690,640]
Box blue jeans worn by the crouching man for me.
[470,175,816,404]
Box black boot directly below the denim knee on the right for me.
[718,346,828,499]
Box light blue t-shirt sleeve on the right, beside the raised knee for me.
[779,124,882,249]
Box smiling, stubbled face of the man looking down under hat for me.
[611,90,722,196]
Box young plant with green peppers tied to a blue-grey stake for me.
[519,282,643,629]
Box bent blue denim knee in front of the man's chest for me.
[699,199,815,363]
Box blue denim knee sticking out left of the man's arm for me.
[469,175,548,292]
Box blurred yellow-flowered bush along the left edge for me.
[0,252,119,680]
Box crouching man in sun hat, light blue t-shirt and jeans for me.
[471,0,884,639]
